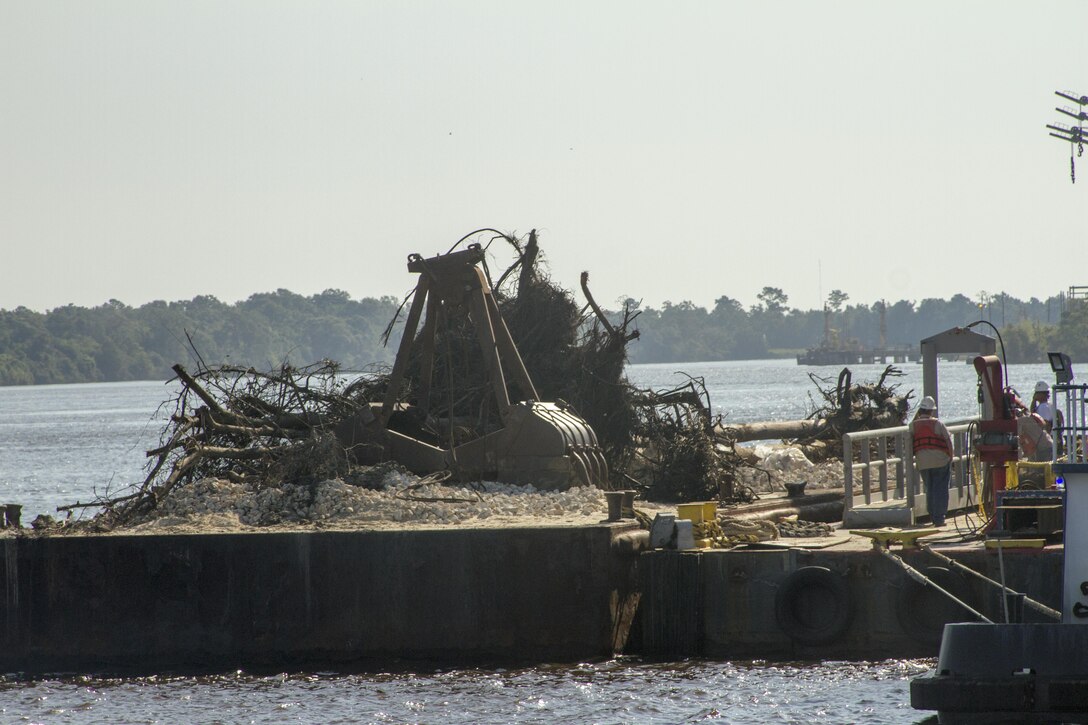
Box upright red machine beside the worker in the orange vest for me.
[975,355,1018,509]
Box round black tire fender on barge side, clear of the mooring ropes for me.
[775,566,854,646]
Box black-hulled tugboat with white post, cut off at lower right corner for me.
[911,353,1088,724]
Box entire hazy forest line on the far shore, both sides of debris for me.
[0,287,1088,385]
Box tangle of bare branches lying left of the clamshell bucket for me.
[59,360,370,529]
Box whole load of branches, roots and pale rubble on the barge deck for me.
[53,230,910,530]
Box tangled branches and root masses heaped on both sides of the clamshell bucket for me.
[64,230,765,528]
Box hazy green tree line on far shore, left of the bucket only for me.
[0,290,398,385]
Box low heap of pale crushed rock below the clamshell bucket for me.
[140,470,607,526]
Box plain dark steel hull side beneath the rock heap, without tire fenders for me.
[0,526,634,675]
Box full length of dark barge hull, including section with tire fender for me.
[0,500,1062,675]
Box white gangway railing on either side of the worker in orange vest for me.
[842,420,978,520]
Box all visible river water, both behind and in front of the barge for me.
[0,360,1051,723]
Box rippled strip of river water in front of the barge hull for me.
[0,660,927,725]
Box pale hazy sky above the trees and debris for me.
[0,0,1088,310]
